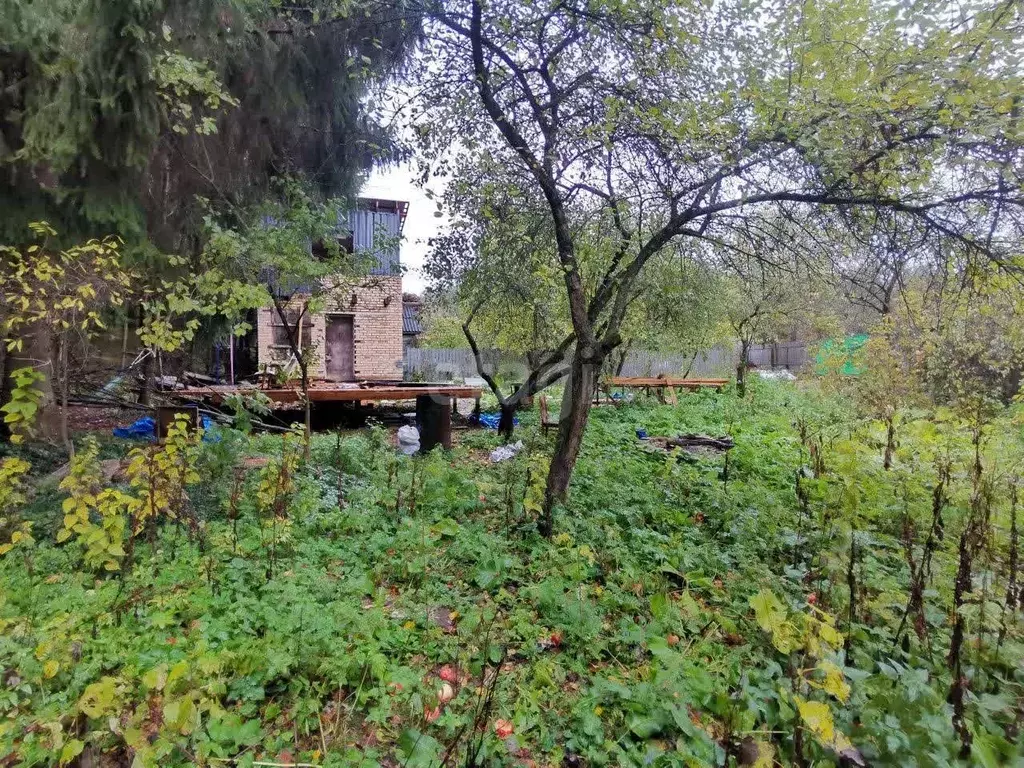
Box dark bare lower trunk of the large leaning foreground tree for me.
[538,349,601,537]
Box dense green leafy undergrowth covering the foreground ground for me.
[0,383,1024,767]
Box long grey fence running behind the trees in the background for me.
[404,341,809,381]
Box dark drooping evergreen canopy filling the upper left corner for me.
[0,0,420,252]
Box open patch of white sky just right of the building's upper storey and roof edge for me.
[359,164,445,293]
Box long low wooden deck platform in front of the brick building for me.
[172,382,482,403]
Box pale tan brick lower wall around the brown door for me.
[256,276,402,381]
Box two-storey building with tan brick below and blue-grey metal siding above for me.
[256,199,408,381]
